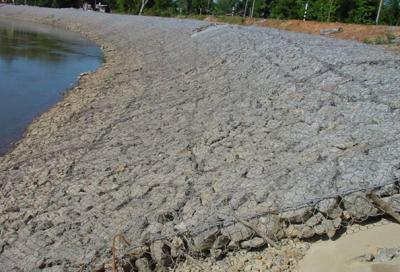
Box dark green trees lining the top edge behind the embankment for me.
[11,0,400,25]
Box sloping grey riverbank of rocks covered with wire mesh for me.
[0,6,400,271]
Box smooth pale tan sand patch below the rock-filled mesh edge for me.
[299,220,400,272]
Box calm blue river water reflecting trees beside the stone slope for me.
[0,19,102,156]
